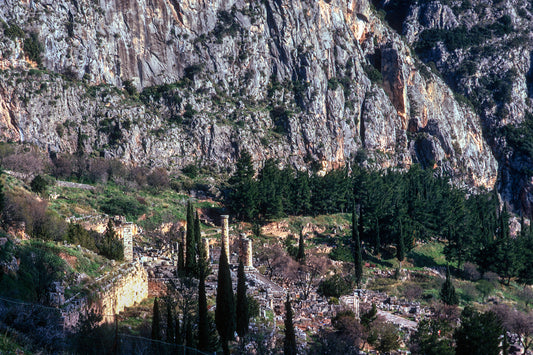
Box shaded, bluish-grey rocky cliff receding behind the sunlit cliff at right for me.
[376,0,533,217]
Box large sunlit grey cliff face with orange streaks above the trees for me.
[0,0,497,187]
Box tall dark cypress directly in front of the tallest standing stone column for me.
[215,236,235,354]
